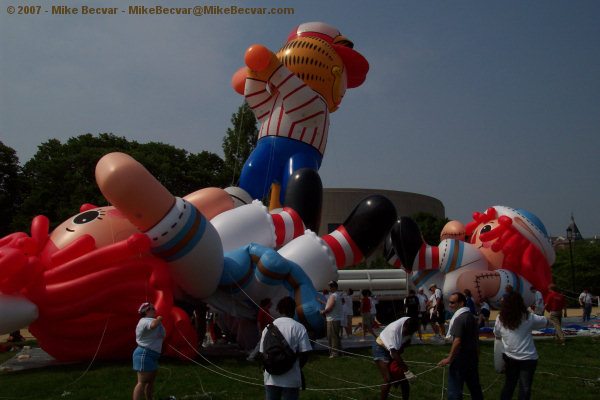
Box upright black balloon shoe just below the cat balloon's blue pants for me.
[284,168,323,232]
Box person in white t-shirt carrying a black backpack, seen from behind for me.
[260,296,312,400]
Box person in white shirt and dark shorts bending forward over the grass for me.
[373,317,419,400]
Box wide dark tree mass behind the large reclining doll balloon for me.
[13,133,230,231]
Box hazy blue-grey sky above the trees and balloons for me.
[0,0,600,236]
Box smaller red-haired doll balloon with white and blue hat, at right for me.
[387,206,555,307]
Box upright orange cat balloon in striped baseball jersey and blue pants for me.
[232,22,369,207]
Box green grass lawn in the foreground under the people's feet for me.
[0,337,600,400]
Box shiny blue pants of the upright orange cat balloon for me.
[240,136,323,204]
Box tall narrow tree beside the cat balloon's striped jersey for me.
[222,102,258,186]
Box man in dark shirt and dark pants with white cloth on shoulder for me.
[438,292,483,400]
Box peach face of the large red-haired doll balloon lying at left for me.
[50,207,139,249]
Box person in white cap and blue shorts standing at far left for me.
[133,303,165,400]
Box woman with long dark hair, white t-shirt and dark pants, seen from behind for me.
[494,292,550,400]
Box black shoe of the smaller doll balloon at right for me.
[386,216,423,272]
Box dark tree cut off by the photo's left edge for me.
[0,141,21,237]
